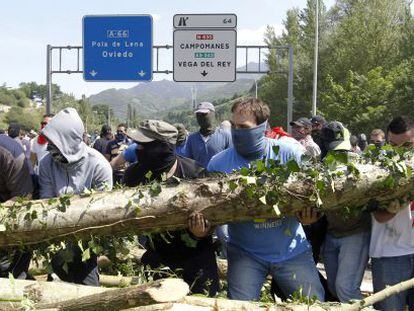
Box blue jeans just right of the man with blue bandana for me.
[322,232,370,302]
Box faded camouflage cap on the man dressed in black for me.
[127,120,178,145]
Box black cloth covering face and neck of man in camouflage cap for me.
[124,141,176,187]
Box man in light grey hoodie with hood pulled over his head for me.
[39,108,112,286]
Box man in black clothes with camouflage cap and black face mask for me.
[124,120,219,296]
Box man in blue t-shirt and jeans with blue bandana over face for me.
[207,98,324,301]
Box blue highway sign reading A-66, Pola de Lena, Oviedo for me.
[83,15,153,81]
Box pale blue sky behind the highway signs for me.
[0,0,334,98]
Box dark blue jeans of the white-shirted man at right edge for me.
[372,254,414,311]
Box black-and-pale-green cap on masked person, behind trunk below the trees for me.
[321,121,352,151]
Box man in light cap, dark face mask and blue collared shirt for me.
[183,102,232,167]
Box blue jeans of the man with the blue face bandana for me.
[227,244,325,301]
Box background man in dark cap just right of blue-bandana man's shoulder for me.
[290,118,321,158]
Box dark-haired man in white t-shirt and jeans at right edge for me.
[370,117,414,311]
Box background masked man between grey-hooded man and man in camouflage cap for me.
[105,123,131,184]
